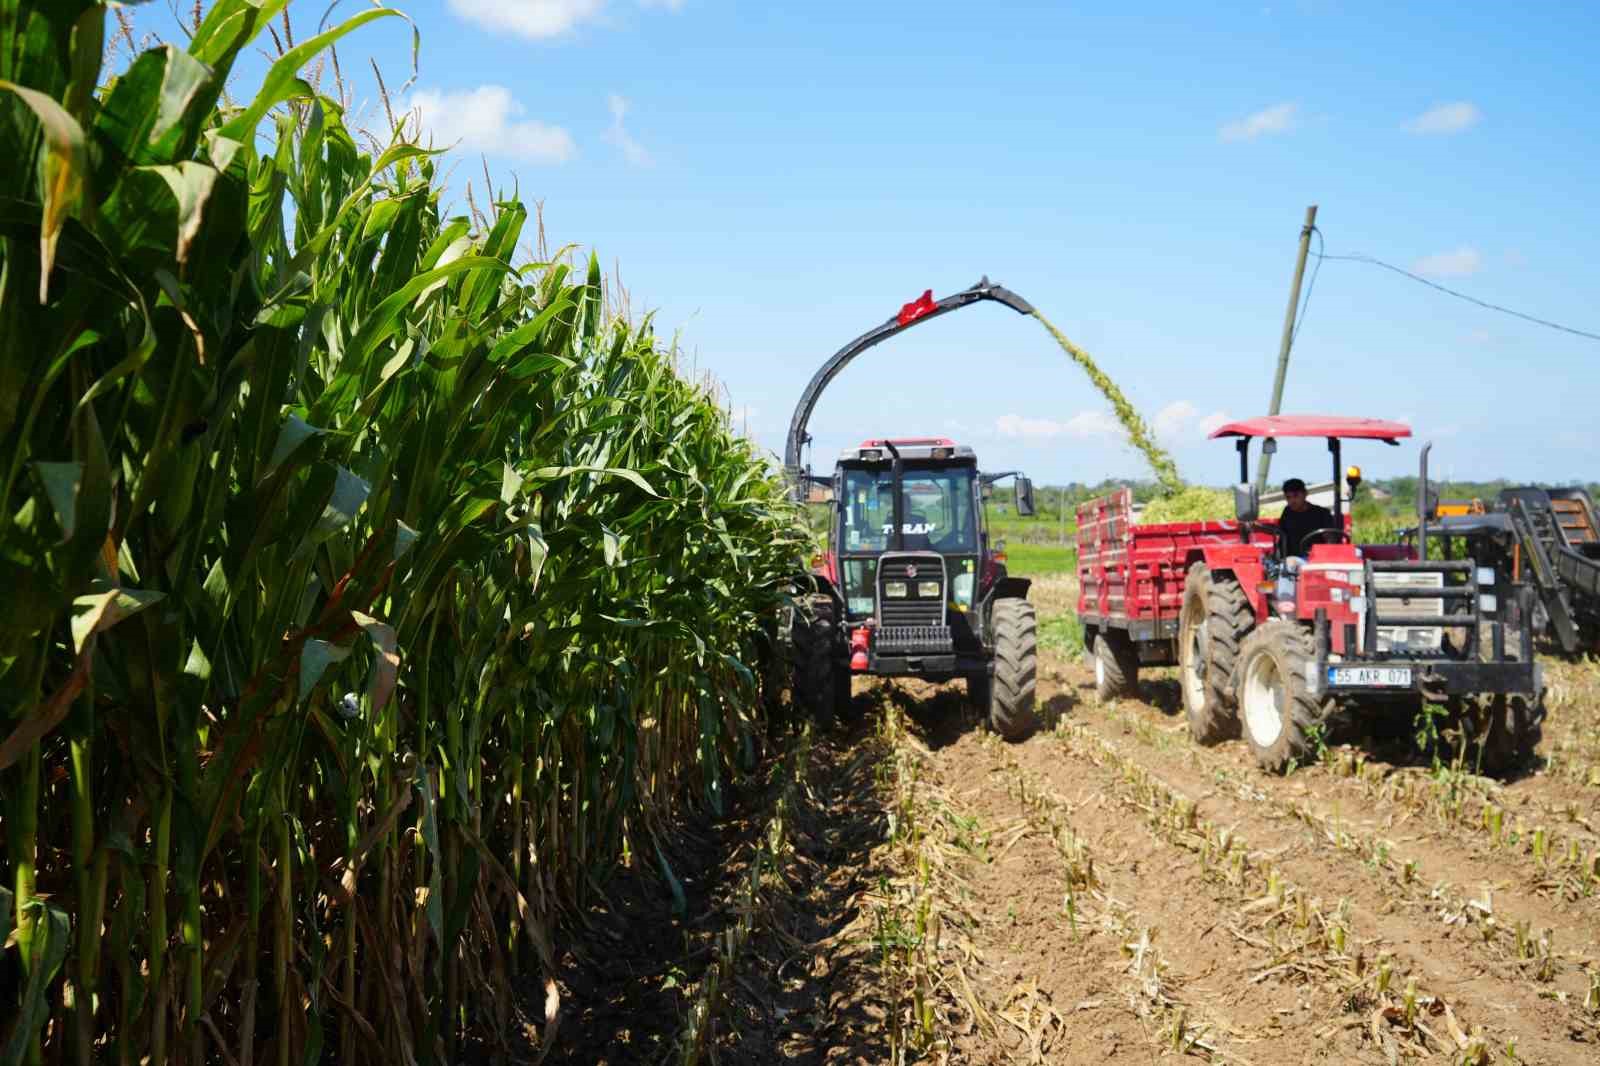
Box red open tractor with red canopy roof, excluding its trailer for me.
[1178,416,1541,770]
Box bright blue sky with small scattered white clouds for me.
[124,0,1600,483]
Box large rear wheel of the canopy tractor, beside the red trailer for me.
[1178,562,1256,744]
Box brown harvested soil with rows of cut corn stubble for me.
[549,579,1600,1066]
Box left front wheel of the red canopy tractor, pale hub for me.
[1238,618,1333,773]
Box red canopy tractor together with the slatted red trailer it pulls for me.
[1078,415,1542,771]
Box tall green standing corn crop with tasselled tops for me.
[0,0,805,1066]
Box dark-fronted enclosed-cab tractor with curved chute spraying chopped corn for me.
[786,279,1037,739]
